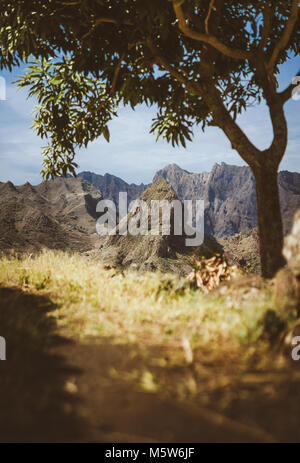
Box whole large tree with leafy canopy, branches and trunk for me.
[0,0,300,277]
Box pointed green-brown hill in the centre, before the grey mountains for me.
[96,179,222,275]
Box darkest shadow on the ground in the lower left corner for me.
[0,288,84,442]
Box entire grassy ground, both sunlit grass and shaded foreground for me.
[0,251,300,441]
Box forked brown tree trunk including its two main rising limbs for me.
[192,73,288,278]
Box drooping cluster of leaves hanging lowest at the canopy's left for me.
[15,57,116,179]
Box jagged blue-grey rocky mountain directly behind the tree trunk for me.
[153,163,300,237]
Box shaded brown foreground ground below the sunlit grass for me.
[0,288,300,443]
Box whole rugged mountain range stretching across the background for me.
[0,163,300,258]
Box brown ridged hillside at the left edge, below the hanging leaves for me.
[0,178,102,251]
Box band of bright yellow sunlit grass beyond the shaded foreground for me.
[0,251,292,346]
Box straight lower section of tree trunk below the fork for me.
[252,165,285,278]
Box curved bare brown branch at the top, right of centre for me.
[173,0,253,60]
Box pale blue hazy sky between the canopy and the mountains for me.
[0,56,300,185]
